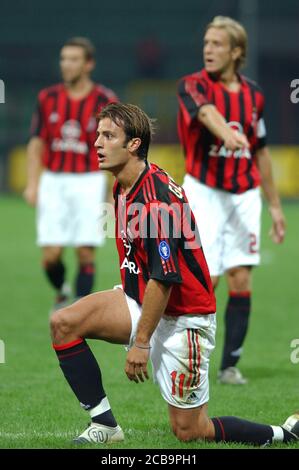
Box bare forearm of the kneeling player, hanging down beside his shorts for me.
[135,279,171,345]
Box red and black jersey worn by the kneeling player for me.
[114,164,216,316]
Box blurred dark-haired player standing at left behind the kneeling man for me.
[24,37,117,307]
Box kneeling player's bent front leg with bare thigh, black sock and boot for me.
[51,289,131,443]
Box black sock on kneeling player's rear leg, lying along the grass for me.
[212,416,273,445]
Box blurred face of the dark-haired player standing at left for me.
[60,46,94,85]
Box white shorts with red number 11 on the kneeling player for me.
[116,286,216,408]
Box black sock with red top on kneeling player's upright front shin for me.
[53,340,117,427]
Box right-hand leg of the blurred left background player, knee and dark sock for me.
[75,246,96,298]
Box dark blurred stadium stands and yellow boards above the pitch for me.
[0,0,299,193]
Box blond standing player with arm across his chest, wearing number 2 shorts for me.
[178,16,285,384]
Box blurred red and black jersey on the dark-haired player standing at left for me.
[31,83,117,173]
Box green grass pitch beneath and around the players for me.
[0,196,299,449]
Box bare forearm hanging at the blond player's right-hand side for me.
[257,147,281,208]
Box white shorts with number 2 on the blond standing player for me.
[183,174,262,276]
